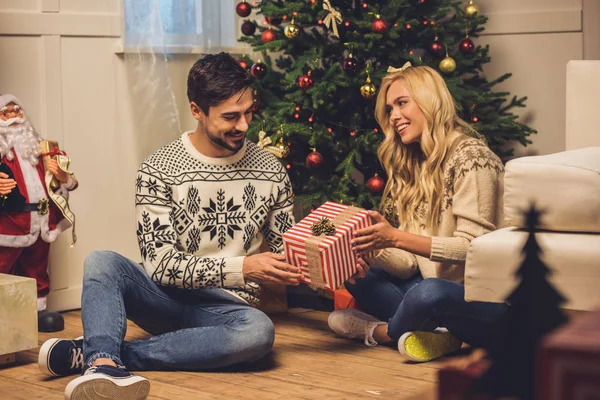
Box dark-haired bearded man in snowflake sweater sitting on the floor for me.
[39,53,301,399]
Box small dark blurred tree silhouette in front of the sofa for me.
[480,205,566,400]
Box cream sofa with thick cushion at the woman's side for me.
[465,61,600,310]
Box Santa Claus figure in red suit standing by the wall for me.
[0,94,77,332]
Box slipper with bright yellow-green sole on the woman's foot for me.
[398,331,462,362]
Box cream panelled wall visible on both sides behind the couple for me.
[0,0,599,309]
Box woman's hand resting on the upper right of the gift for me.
[350,211,400,254]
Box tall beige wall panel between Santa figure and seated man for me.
[49,38,140,309]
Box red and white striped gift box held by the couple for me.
[283,201,371,291]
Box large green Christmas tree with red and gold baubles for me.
[236,0,535,208]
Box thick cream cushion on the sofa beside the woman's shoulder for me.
[504,147,600,232]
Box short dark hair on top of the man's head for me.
[187,52,252,115]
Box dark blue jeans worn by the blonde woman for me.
[345,266,508,347]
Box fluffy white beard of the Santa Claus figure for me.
[0,120,42,166]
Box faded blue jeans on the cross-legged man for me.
[81,251,275,371]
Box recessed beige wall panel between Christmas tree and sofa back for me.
[478,32,582,156]
